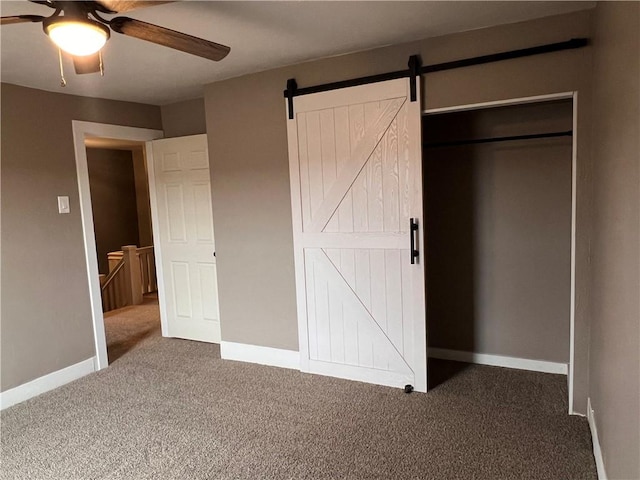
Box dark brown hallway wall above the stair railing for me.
[87,148,139,274]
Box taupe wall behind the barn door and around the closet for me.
[205,11,592,412]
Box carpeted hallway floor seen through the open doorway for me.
[104,293,160,364]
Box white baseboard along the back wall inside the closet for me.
[428,348,569,375]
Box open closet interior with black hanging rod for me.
[422,94,575,396]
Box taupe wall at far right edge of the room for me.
[589,2,640,480]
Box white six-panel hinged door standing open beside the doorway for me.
[150,134,220,343]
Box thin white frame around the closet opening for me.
[422,91,578,414]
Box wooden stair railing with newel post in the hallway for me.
[100,245,158,312]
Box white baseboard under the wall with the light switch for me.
[0,357,96,410]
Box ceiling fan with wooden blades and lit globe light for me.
[0,0,231,74]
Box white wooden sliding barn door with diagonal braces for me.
[288,78,427,392]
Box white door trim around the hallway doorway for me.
[71,120,164,370]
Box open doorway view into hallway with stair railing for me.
[85,137,160,363]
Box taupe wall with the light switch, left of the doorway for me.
[0,83,162,391]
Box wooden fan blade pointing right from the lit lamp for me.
[109,17,231,61]
